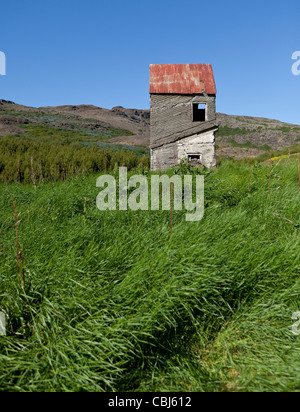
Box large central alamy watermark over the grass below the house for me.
[96,167,204,222]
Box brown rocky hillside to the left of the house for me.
[0,100,149,146]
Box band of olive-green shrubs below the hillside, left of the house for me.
[0,136,149,184]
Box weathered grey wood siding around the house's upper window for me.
[150,94,217,148]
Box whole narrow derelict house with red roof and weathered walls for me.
[150,64,218,170]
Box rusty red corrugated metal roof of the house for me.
[150,64,217,94]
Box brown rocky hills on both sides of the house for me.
[0,100,300,159]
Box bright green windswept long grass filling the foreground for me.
[0,158,300,392]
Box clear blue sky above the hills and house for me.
[0,0,300,124]
